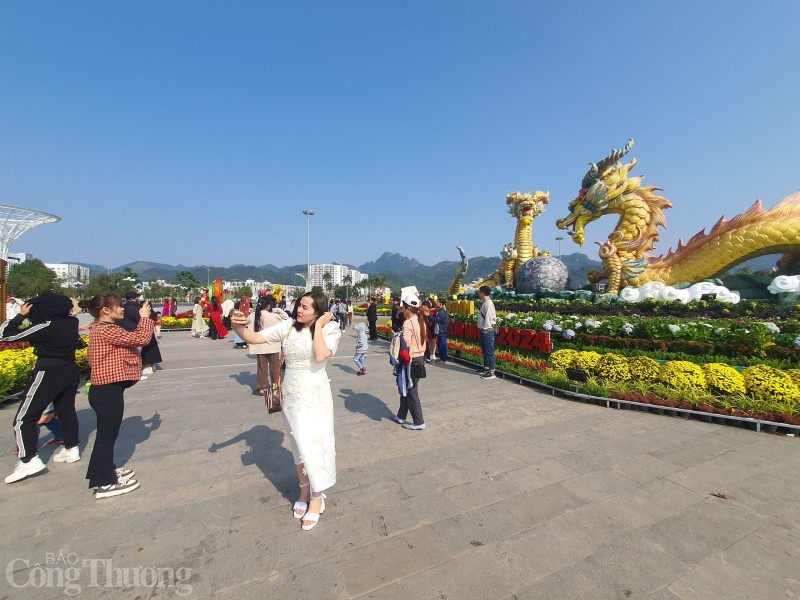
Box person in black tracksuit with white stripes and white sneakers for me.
[0,292,86,483]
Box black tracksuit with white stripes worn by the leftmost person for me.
[0,315,85,462]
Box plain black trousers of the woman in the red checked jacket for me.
[86,381,132,487]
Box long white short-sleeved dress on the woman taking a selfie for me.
[258,320,342,492]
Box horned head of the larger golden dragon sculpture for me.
[556,138,636,246]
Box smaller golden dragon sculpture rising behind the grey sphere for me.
[469,190,550,288]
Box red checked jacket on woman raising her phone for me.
[89,317,154,385]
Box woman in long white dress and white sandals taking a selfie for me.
[231,292,342,531]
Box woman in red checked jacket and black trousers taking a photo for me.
[79,294,153,499]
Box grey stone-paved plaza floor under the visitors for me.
[0,316,800,600]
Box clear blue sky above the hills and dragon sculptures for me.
[0,0,800,266]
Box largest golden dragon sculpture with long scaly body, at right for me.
[556,139,800,294]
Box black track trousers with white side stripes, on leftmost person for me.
[14,359,81,462]
